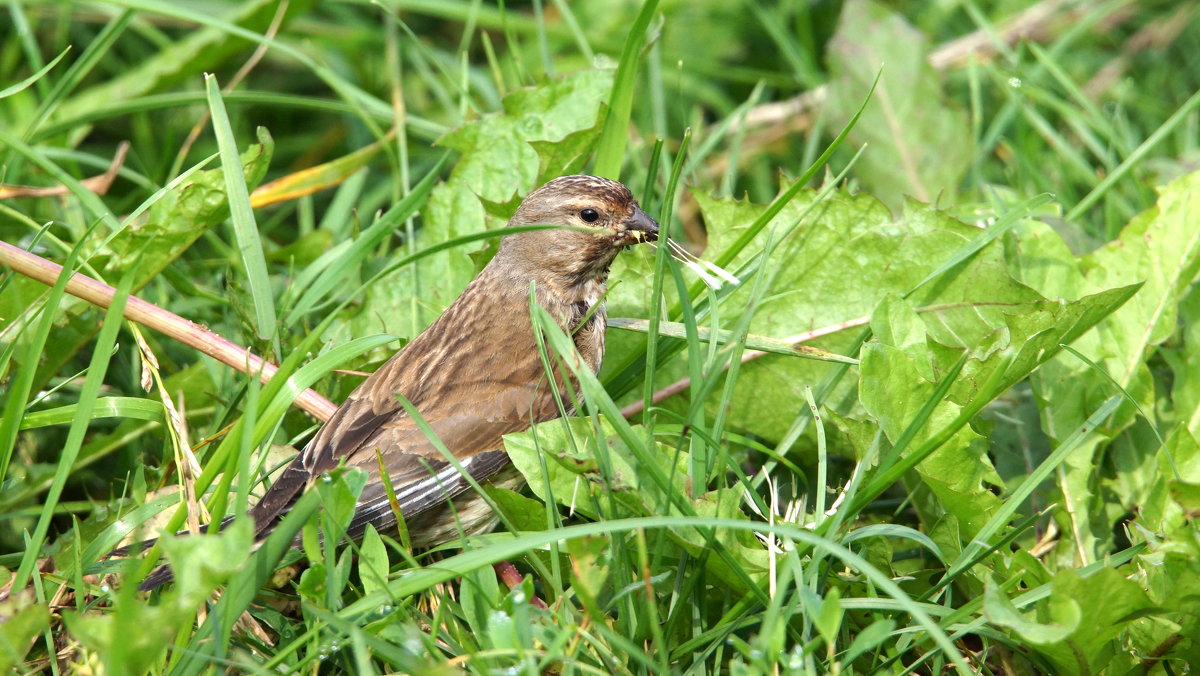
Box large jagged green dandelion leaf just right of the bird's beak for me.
[686,184,1039,438]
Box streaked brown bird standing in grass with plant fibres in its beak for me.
[142,175,659,590]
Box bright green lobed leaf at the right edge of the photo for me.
[1013,172,1200,563]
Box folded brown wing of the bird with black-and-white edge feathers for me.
[253,280,558,534]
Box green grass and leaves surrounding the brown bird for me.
[0,0,1200,675]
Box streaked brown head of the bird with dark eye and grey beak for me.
[497,175,659,280]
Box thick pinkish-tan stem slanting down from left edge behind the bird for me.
[0,241,337,423]
